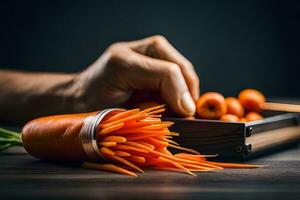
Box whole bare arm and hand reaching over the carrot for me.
[0,36,199,122]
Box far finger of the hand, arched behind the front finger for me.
[127,36,200,101]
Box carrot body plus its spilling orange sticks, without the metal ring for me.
[22,105,264,176]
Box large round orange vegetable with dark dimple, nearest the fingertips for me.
[196,92,227,119]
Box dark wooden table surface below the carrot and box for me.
[0,146,300,200]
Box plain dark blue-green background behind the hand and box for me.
[0,0,300,97]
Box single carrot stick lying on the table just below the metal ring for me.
[81,162,137,177]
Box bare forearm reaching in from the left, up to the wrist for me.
[0,70,77,123]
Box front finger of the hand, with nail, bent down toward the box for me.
[126,52,196,116]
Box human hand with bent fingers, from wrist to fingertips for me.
[74,36,199,116]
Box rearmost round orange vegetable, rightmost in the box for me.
[238,89,266,112]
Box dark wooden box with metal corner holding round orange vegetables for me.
[167,111,300,160]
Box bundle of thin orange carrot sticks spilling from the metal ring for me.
[82,105,263,176]
